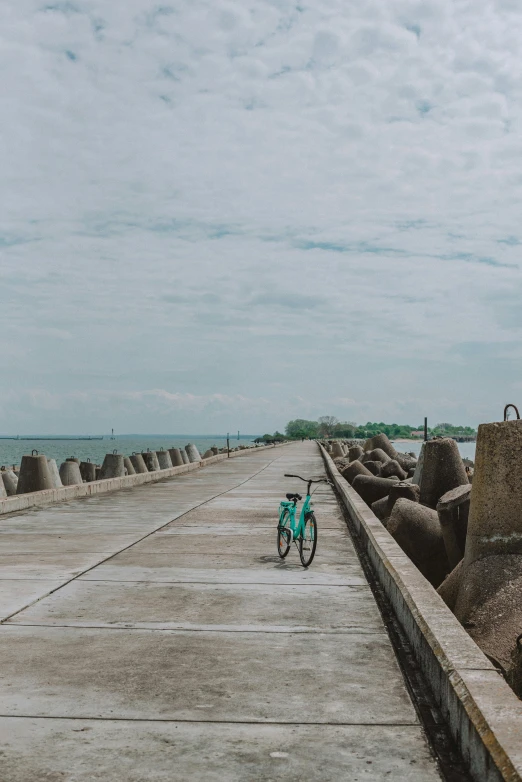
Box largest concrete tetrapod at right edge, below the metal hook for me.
[455,420,522,679]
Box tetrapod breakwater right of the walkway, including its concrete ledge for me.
[323,420,522,780]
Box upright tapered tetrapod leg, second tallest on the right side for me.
[413,437,469,509]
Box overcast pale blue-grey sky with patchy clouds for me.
[0,0,522,434]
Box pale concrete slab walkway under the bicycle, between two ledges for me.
[0,443,440,782]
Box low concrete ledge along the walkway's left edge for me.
[0,443,287,516]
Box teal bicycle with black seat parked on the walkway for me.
[277,473,331,567]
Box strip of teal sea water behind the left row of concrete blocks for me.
[0,434,259,466]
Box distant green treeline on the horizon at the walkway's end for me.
[259,415,476,441]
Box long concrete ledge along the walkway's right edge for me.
[319,446,522,782]
